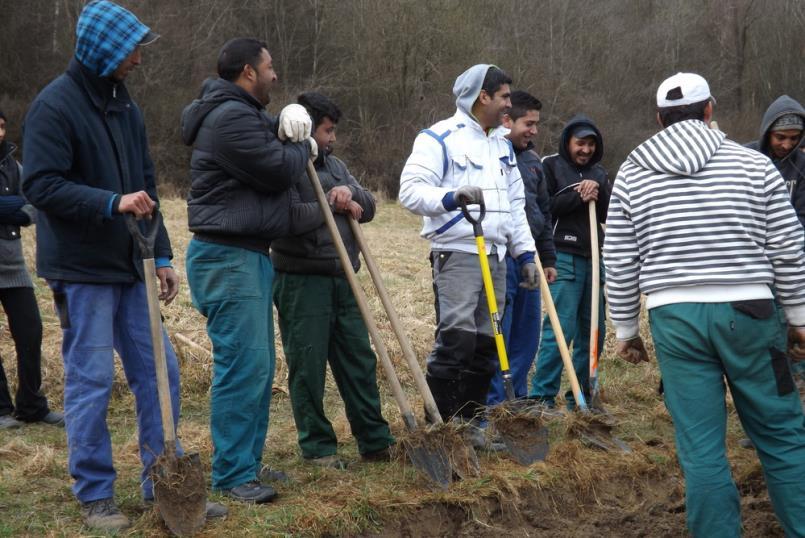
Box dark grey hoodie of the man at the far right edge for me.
[746,95,805,226]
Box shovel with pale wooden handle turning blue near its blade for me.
[535,245,631,452]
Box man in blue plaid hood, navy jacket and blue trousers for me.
[23,1,223,531]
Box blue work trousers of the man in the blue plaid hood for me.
[49,281,181,503]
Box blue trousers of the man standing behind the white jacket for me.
[487,254,542,406]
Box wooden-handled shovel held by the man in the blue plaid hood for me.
[126,210,207,536]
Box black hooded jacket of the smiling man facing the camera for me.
[542,114,612,257]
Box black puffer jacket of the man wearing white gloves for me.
[182,79,317,252]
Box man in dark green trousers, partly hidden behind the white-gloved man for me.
[271,92,394,469]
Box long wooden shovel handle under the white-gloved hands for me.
[307,161,416,431]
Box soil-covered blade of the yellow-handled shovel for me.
[489,400,549,465]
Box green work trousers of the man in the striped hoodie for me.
[649,301,805,538]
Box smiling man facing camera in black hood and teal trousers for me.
[529,115,611,408]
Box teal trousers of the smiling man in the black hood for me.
[529,252,606,408]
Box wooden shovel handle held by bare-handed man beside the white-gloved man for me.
[349,216,443,424]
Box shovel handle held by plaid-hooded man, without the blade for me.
[125,209,176,454]
